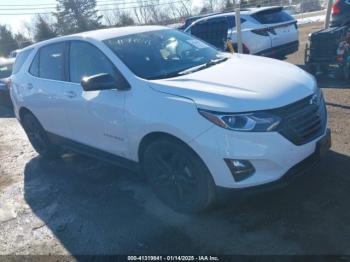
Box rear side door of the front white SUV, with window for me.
[27,42,71,137]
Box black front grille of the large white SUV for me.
[273,95,327,145]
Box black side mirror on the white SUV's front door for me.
[81,74,126,91]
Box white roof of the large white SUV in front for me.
[21,25,170,52]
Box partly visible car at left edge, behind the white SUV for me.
[0,59,14,107]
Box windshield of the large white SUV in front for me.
[104,29,226,79]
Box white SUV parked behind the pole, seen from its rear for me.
[184,7,299,57]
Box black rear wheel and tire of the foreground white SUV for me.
[22,113,59,158]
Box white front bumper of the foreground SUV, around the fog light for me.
[191,126,329,189]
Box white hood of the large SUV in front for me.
[149,54,316,112]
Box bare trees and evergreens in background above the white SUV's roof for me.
[0,0,234,56]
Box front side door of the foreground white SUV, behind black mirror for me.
[66,40,127,155]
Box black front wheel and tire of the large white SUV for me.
[141,138,215,213]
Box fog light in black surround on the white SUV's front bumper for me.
[224,158,255,182]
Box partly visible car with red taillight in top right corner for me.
[331,0,350,27]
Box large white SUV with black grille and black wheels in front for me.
[11,26,330,212]
